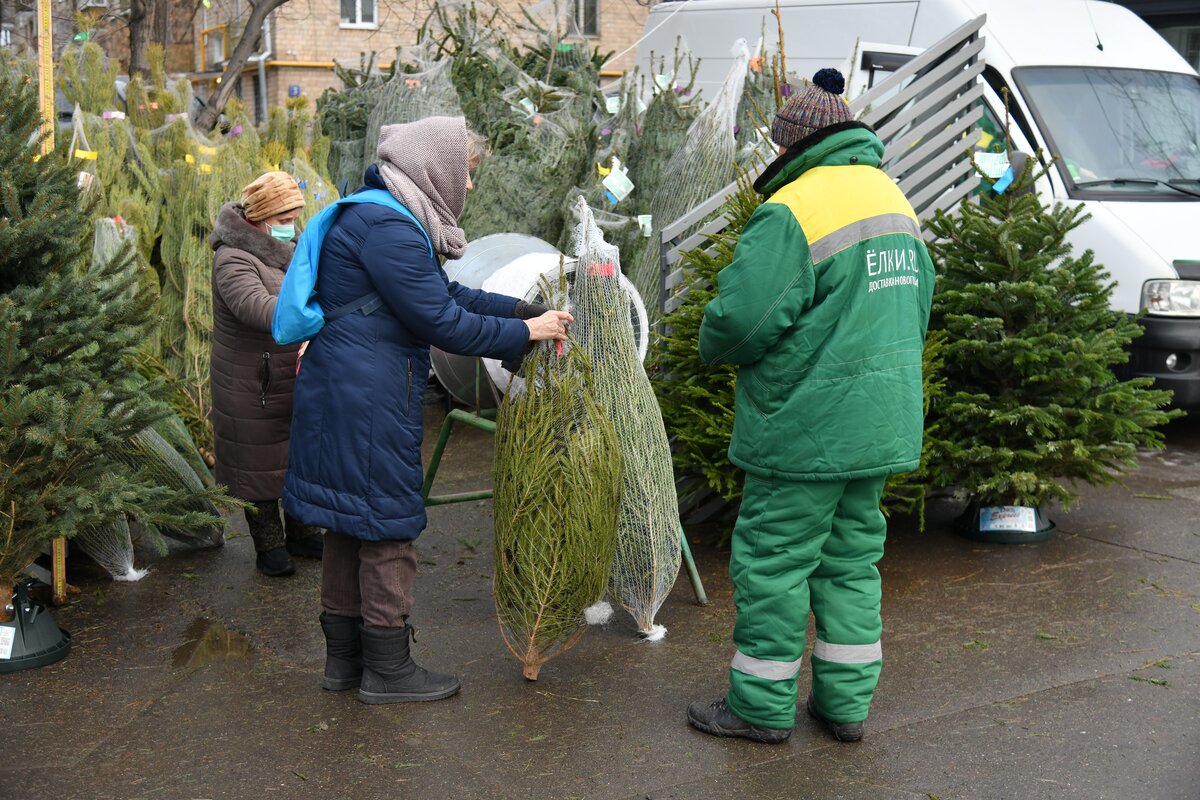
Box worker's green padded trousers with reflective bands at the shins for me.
[725,475,887,728]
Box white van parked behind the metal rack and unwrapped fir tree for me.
[637,0,1200,408]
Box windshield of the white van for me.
[1013,67,1200,200]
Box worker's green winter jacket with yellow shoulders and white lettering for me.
[700,122,934,481]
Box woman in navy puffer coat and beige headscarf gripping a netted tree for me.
[283,118,572,703]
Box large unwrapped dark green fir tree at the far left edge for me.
[0,64,220,591]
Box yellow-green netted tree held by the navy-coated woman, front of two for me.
[493,273,623,680]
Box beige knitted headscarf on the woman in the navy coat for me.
[376,116,468,258]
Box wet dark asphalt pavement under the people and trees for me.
[0,407,1200,800]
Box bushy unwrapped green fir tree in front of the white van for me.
[926,158,1172,506]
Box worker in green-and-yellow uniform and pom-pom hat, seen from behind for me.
[688,70,934,742]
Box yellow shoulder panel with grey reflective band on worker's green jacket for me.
[767,164,920,264]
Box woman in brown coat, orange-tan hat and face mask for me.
[210,172,323,577]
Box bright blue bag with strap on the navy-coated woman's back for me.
[271,190,433,344]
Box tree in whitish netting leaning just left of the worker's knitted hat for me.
[630,38,750,319]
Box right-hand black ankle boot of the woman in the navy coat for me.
[359,625,462,705]
